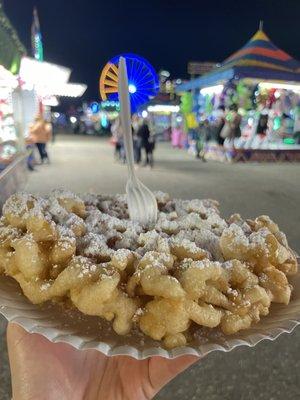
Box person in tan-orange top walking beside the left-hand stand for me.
[29,115,52,164]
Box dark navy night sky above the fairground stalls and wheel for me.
[4,0,300,99]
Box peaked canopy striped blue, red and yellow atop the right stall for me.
[176,29,300,92]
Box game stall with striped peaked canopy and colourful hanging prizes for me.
[176,27,300,161]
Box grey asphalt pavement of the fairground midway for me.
[0,135,300,400]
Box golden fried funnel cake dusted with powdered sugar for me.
[0,190,297,348]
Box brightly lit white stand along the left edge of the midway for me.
[0,2,86,207]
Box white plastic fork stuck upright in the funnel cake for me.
[118,57,157,226]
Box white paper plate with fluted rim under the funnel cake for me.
[0,273,300,360]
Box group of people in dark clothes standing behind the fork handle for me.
[111,115,155,168]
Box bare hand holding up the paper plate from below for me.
[7,324,199,400]
